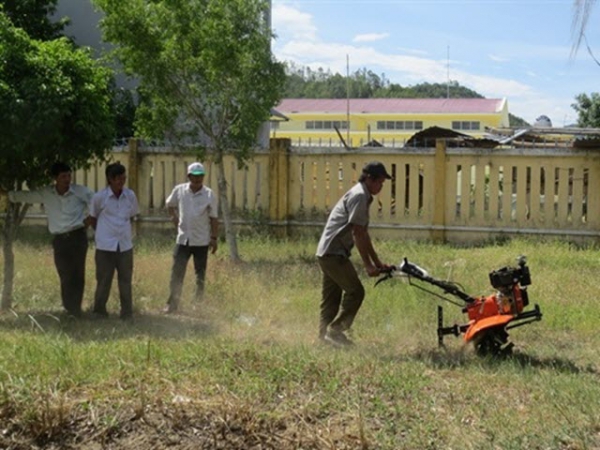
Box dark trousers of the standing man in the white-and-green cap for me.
[167,244,208,310]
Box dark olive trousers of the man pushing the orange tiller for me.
[318,256,365,338]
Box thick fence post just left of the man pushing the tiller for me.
[269,138,291,236]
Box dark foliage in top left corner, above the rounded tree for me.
[0,0,68,41]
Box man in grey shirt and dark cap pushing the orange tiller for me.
[317,161,392,346]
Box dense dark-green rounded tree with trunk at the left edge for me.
[0,12,114,309]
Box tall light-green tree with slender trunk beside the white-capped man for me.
[95,0,285,260]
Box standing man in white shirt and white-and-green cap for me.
[164,162,219,313]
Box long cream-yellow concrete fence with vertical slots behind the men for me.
[18,139,600,243]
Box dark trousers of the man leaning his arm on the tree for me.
[52,228,88,316]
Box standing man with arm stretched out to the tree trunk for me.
[8,162,94,317]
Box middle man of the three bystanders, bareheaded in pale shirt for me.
[90,162,139,320]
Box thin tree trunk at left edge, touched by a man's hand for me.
[0,203,28,311]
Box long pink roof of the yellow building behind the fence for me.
[275,98,505,114]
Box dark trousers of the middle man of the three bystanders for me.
[94,249,133,319]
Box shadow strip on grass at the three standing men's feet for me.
[0,311,217,342]
